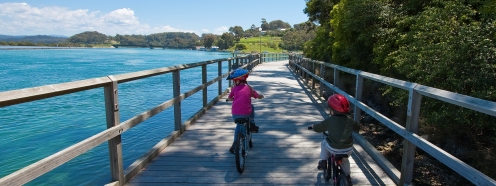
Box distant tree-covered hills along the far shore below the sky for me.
[0,18,315,52]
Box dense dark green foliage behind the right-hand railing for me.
[304,0,496,182]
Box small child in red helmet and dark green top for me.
[313,94,360,183]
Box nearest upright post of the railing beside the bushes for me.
[400,84,422,185]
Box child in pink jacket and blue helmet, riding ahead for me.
[227,68,264,154]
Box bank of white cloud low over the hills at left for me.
[0,3,195,36]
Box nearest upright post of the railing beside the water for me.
[103,76,125,186]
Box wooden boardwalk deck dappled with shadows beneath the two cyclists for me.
[126,61,395,186]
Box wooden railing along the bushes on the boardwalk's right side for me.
[289,55,496,185]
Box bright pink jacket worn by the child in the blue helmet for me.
[229,84,258,115]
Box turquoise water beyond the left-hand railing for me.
[0,48,231,185]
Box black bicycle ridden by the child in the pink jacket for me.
[234,118,253,174]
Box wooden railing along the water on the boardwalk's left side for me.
[0,54,288,185]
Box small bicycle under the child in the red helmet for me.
[308,126,352,186]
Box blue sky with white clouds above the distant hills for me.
[0,0,308,37]
